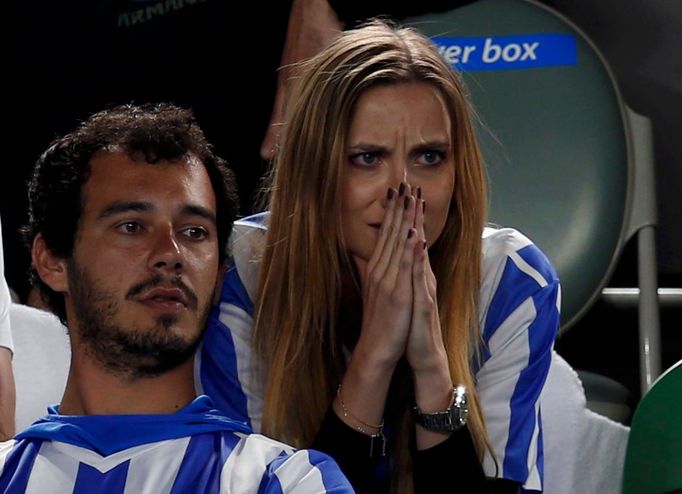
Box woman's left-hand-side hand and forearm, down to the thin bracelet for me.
[333,184,423,434]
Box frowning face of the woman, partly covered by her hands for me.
[341,82,455,267]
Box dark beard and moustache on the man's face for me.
[68,258,211,380]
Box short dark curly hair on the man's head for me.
[22,103,238,322]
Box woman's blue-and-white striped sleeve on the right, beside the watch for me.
[476,229,560,492]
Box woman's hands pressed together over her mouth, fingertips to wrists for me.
[358,183,447,377]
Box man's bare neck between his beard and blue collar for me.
[59,352,196,415]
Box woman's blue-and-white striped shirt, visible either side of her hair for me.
[196,213,560,491]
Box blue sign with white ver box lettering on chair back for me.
[431,34,578,71]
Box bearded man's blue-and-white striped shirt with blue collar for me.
[0,396,353,494]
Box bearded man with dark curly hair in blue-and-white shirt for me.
[0,105,352,494]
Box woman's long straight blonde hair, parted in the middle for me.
[254,21,490,492]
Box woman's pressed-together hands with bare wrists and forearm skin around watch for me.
[333,183,452,449]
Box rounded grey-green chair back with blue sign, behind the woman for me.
[406,0,632,330]
